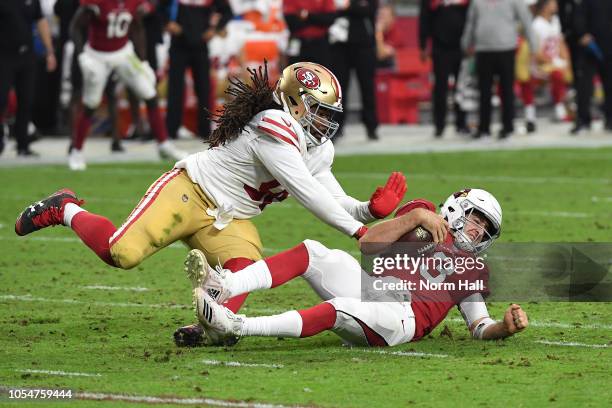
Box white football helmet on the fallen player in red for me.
[440,188,502,254]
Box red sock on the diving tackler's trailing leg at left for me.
[70,211,117,266]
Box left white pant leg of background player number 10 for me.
[78,46,112,109]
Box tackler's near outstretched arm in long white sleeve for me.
[254,138,363,236]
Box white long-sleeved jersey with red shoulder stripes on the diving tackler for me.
[175,109,374,235]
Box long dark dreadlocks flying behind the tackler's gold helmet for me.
[207,60,281,147]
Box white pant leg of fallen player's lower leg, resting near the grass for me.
[328,298,415,346]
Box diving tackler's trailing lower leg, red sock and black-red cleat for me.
[15,189,117,266]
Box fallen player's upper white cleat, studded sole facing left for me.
[185,249,232,304]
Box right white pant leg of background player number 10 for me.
[116,44,157,101]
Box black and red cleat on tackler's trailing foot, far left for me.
[15,189,84,236]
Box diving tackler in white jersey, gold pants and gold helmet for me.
[15,62,406,342]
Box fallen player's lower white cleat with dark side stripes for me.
[193,288,243,346]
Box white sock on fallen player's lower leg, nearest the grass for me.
[240,310,302,337]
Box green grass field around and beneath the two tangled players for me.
[0,149,612,407]
